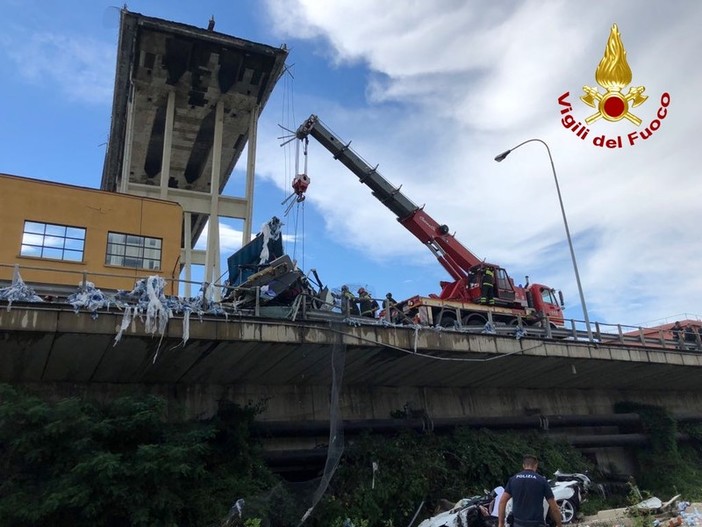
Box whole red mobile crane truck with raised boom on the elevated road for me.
[295,115,563,327]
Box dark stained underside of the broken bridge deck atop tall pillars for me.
[101,9,287,242]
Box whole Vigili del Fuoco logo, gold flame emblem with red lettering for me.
[558,24,670,148]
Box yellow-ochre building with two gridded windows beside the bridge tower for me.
[0,174,183,294]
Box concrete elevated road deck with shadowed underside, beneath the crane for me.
[0,304,702,422]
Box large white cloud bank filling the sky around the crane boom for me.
[259,0,702,323]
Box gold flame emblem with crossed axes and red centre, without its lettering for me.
[580,24,648,126]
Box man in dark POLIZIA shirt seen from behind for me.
[497,454,563,527]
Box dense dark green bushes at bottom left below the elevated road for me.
[0,386,273,527]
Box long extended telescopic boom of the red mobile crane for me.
[295,115,482,281]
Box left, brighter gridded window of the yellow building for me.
[20,221,85,262]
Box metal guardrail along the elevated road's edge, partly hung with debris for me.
[0,263,702,352]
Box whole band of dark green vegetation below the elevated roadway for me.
[0,386,702,527]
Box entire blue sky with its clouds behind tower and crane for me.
[0,0,702,324]
